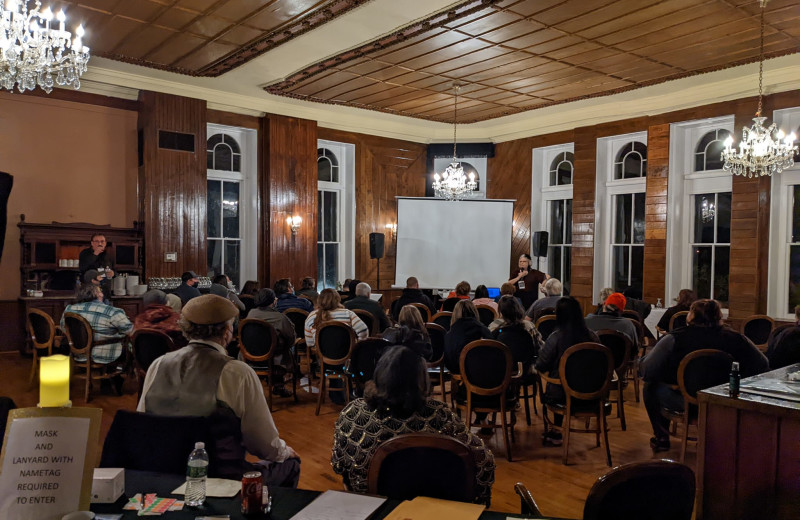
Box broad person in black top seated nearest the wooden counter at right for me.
[639,300,769,452]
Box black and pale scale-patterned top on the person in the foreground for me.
[331,399,495,504]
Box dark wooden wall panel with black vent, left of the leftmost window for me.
[139,91,208,277]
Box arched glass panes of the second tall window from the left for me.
[317,148,344,290]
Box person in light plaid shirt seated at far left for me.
[61,284,133,364]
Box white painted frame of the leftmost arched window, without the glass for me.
[203,123,258,286]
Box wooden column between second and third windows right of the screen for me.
[642,124,670,308]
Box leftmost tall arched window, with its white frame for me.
[206,125,256,287]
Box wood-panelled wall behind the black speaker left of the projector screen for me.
[318,128,427,290]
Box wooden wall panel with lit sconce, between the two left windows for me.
[258,115,317,286]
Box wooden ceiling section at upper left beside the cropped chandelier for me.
[53,0,368,77]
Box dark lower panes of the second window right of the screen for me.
[611,193,645,291]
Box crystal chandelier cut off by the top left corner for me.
[0,0,89,94]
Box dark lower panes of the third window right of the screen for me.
[691,192,731,303]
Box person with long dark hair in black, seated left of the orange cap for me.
[536,296,600,446]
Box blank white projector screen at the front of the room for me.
[395,197,514,289]
